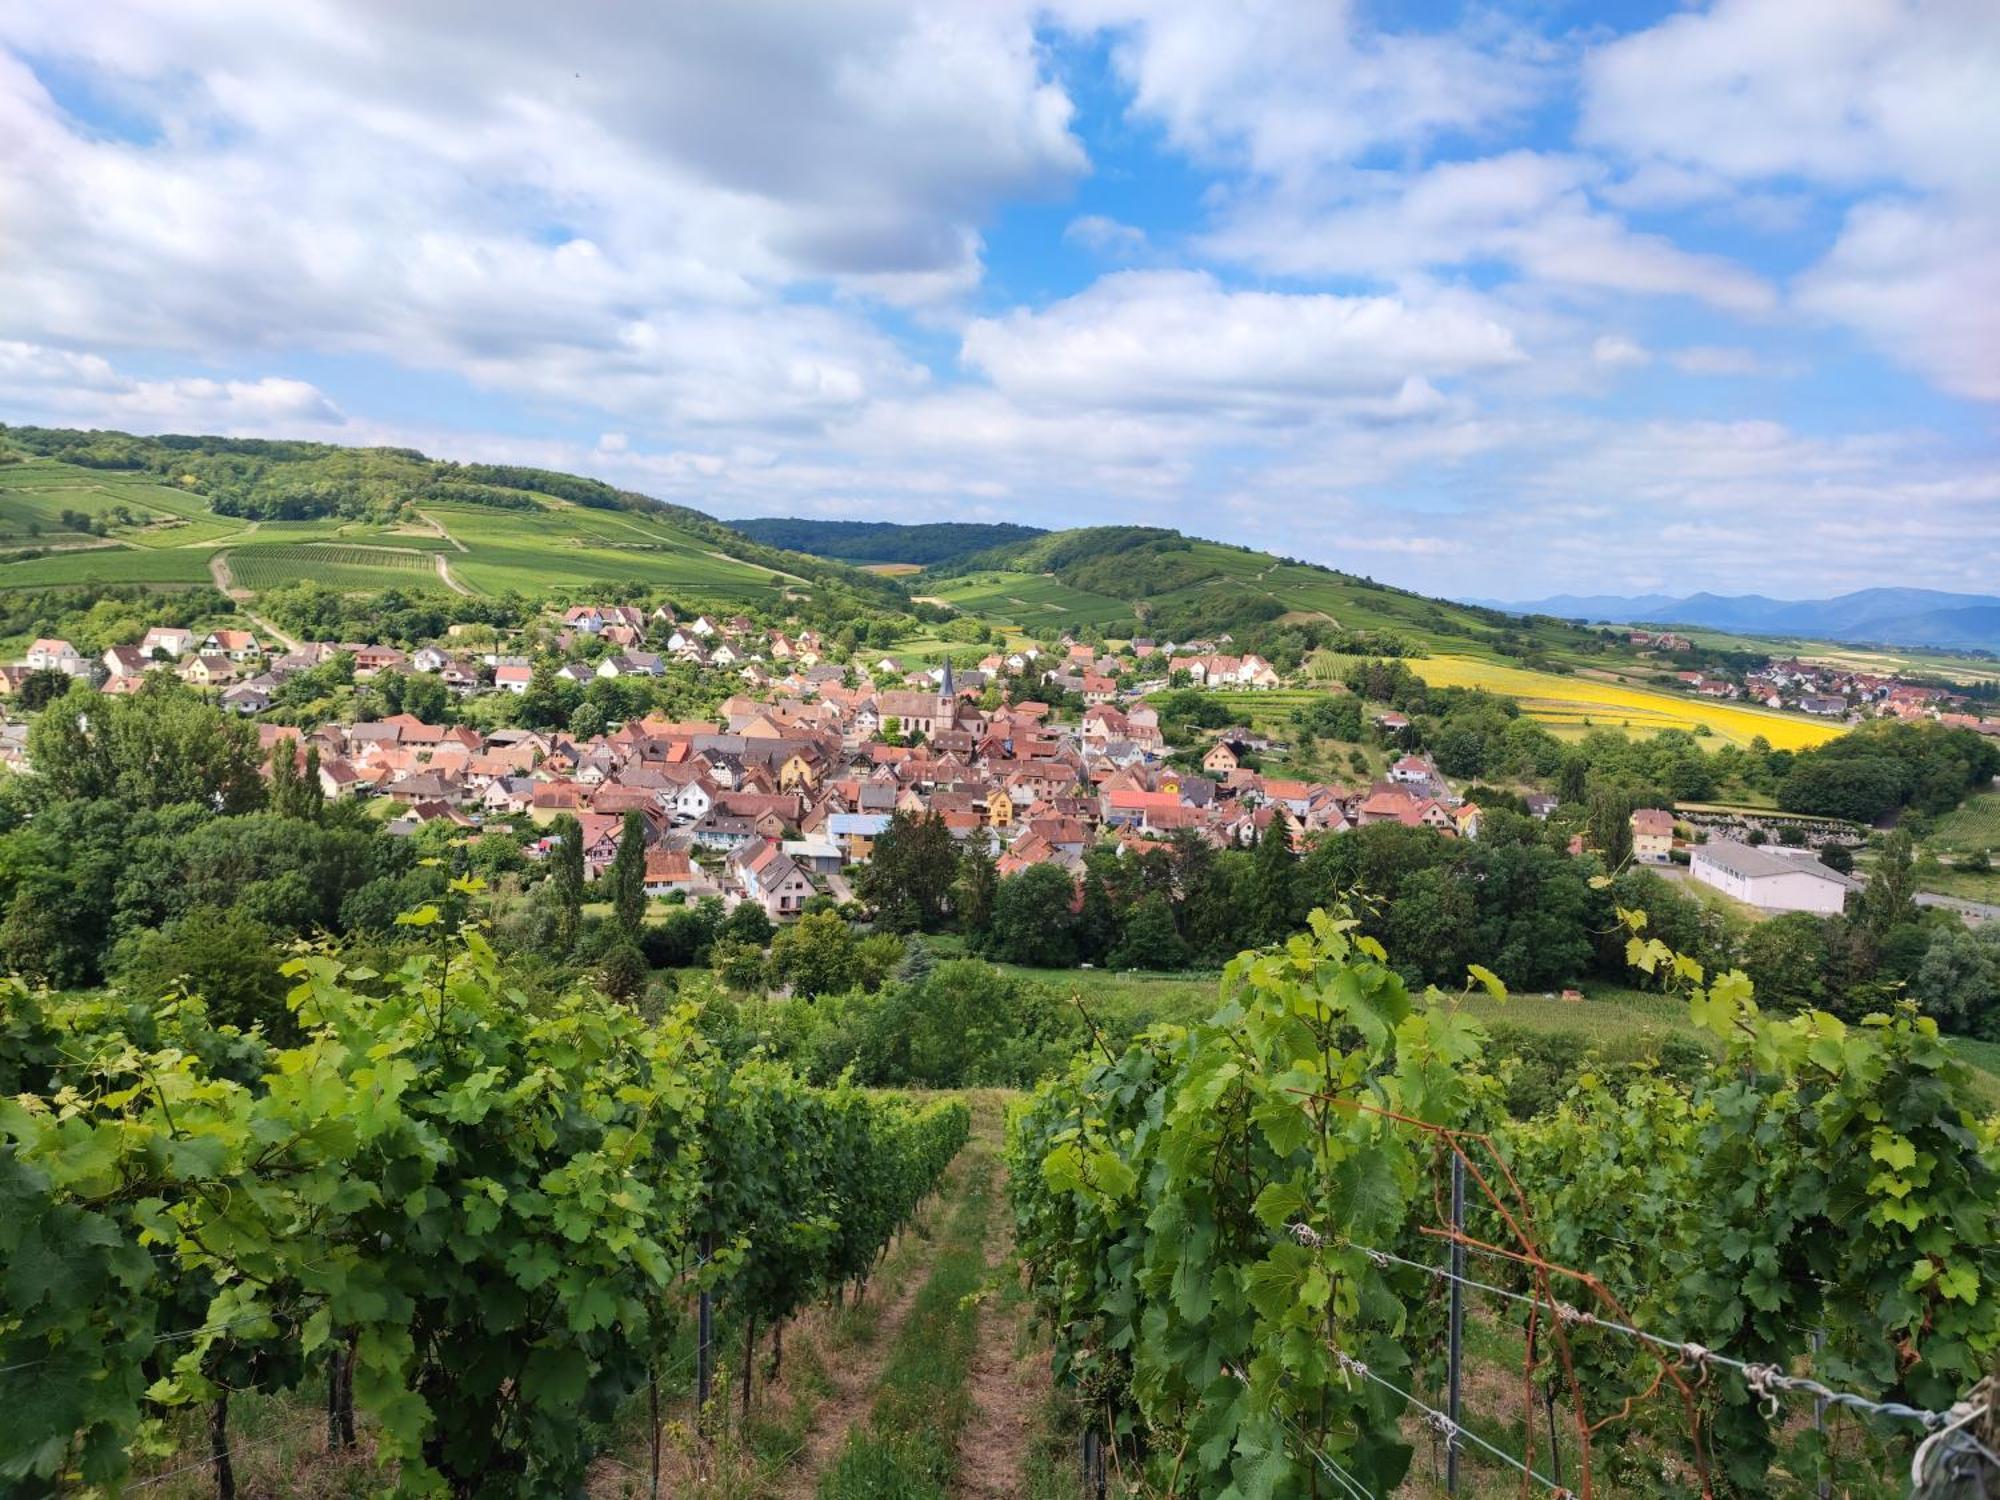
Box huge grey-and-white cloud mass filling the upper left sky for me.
[0,0,1086,428]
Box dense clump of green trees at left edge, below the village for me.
[0,674,484,1000]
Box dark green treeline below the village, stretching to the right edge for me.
[856,804,2000,1038]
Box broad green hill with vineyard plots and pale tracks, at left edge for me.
[0,428,908,610]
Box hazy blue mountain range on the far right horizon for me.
[1466,588,2000,652]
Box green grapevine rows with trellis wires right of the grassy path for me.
[1010,912,2000,1496]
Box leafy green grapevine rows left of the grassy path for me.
[0,882,968,1496]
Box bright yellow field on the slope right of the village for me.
[1408,656,1844,750]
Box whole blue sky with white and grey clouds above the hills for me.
[0,0,2000,598]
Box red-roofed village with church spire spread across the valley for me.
[0,604,1528,918]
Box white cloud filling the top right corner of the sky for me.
[1580,0,2000,400]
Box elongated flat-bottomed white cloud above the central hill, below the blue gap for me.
[964,272,1522,420]
